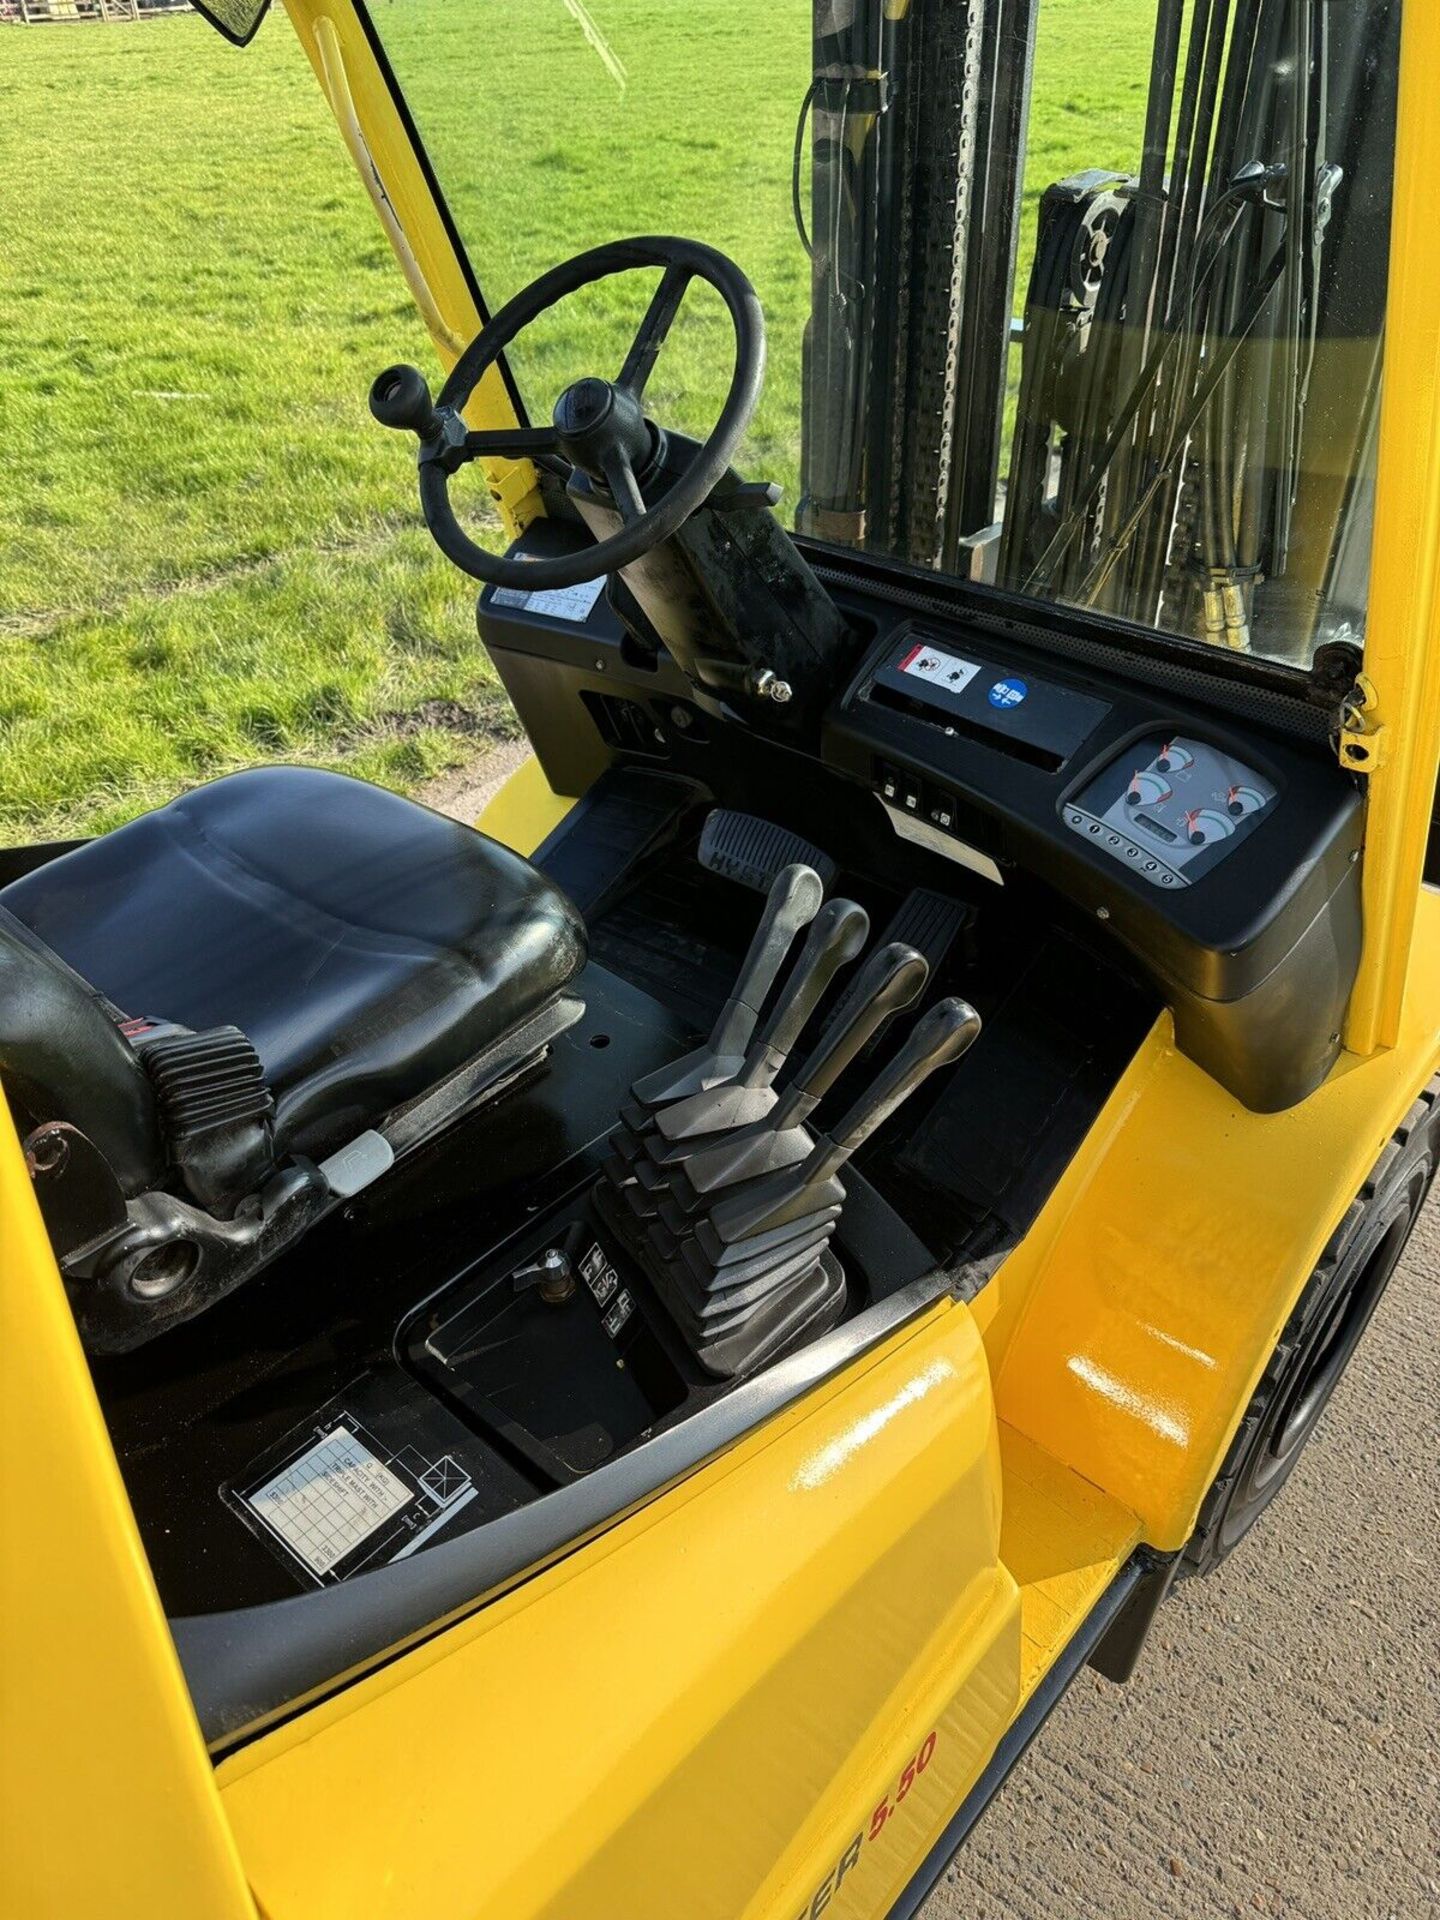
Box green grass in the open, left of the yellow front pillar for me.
[0,15,513,839]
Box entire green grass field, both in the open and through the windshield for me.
[0,0,1152,841]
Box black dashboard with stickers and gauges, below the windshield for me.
[478,522,1363,1112]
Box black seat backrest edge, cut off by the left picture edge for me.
[0,906,165,1194]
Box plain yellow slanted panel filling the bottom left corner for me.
[0,1100,255,1920]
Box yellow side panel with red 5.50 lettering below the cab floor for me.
[221,1306,1021,1920]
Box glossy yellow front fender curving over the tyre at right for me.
[975,893,1440,1549]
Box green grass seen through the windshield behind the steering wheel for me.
[372,0,1154,487]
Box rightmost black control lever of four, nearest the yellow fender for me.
[697,998,979,1261]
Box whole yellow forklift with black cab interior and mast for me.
[0,0,1440,1920]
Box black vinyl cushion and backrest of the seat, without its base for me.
[0,766,586,1351]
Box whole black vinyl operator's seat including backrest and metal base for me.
[0,766,586,1352]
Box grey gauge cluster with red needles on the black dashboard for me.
[1064,733,1277,887]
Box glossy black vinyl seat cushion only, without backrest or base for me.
[0,766,586,1156]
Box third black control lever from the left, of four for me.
[649,941,929,1202]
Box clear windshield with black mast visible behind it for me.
[371,0,1400,666]
